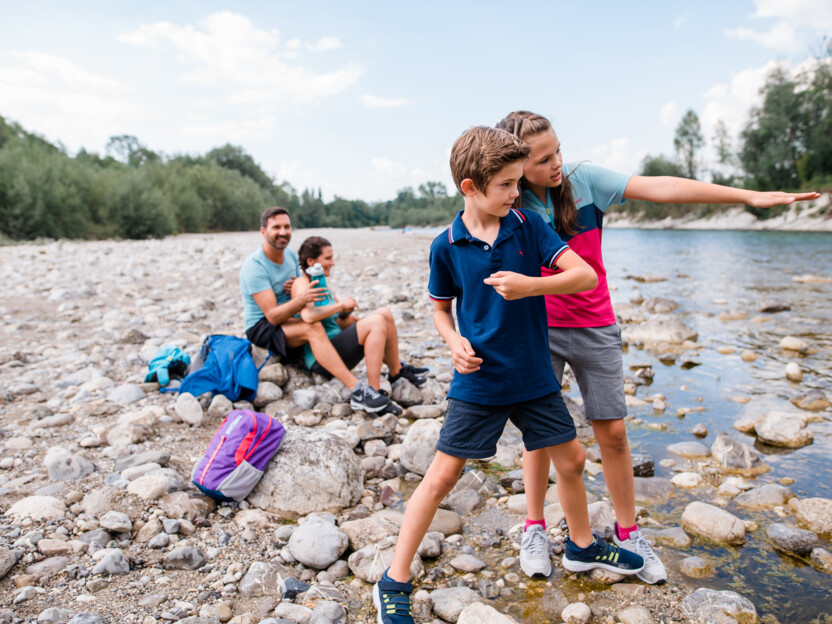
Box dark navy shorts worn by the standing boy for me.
[436,392,577,459]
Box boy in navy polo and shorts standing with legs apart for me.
[373,127,644,624]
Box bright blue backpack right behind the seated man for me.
[179,334,259,402]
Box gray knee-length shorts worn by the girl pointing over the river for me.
[549,325,627,420]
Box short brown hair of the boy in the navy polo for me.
[451,126,531,193]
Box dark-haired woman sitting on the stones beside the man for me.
[292,236,428,412]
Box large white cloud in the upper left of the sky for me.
[118,11,364,103]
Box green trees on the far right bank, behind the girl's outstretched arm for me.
[615,44,832,219]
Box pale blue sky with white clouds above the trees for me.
[0,0,832,201]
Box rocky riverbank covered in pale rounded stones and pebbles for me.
[0,230,832,624]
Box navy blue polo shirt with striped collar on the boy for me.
[428,209,569,405]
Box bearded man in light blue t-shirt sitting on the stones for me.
[240,206,390,412]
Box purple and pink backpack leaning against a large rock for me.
[191,410,286,503]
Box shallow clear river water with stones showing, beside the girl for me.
[604,230,832,622]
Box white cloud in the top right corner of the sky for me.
[725,0,832,52]
